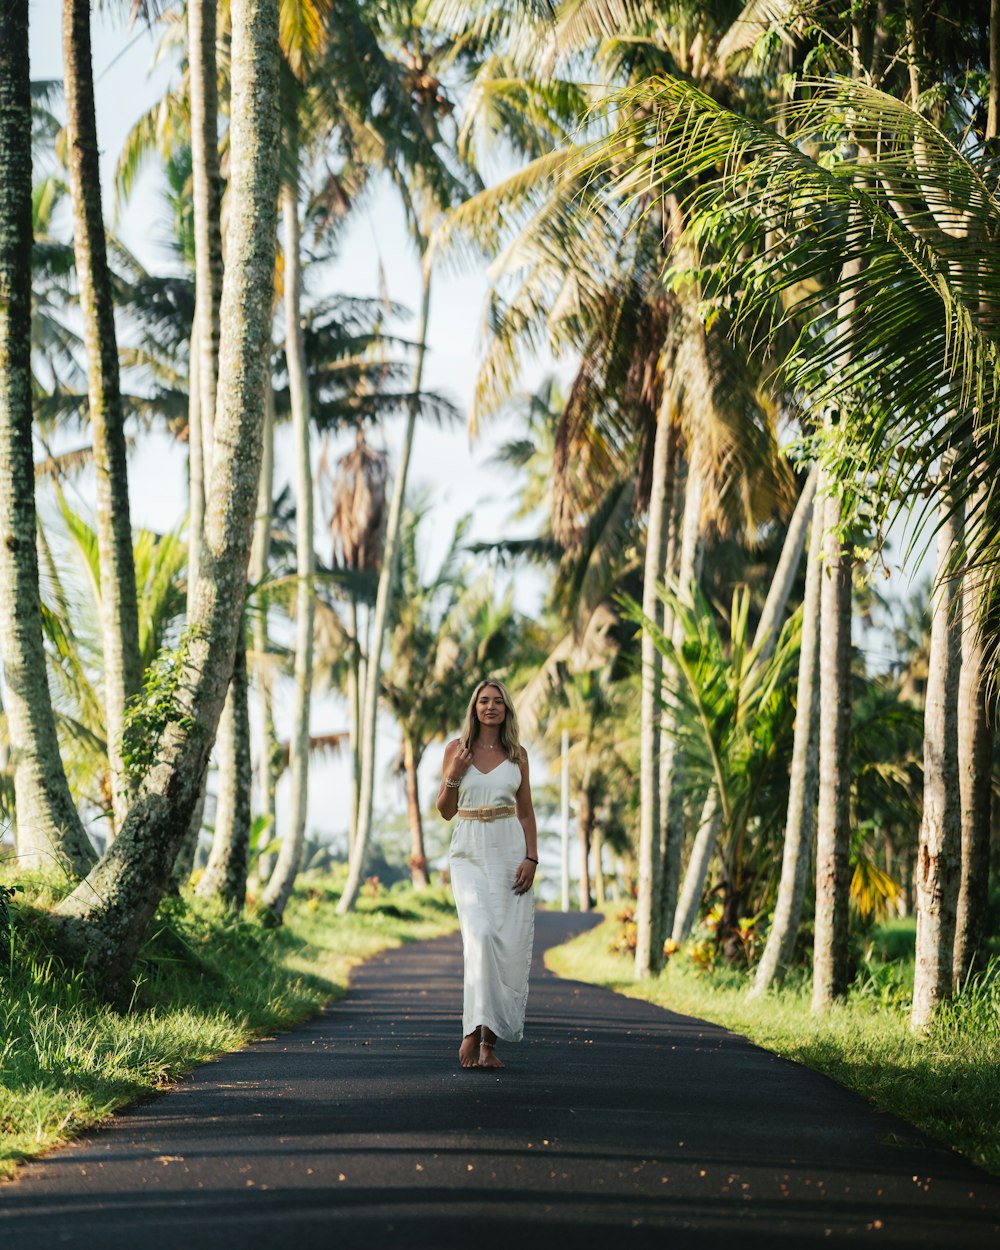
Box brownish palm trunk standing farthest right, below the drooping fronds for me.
[953,570,994,989]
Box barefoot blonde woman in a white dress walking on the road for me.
[438,678,539,1068]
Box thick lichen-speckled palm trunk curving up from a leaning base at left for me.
[56,0,279,996]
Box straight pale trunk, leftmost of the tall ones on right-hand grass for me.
[635,386,675,978]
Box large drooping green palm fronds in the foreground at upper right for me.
[585,31,1000,996]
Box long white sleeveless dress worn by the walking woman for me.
[449,760,535,1041]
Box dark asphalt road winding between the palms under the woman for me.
[0,913,1000,1250]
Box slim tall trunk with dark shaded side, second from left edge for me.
[63,0,143,829]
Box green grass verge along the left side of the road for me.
[0,880,456,1178]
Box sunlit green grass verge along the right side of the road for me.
[546,919,1000,1173]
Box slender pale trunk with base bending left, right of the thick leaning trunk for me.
[264,173,316,923]
